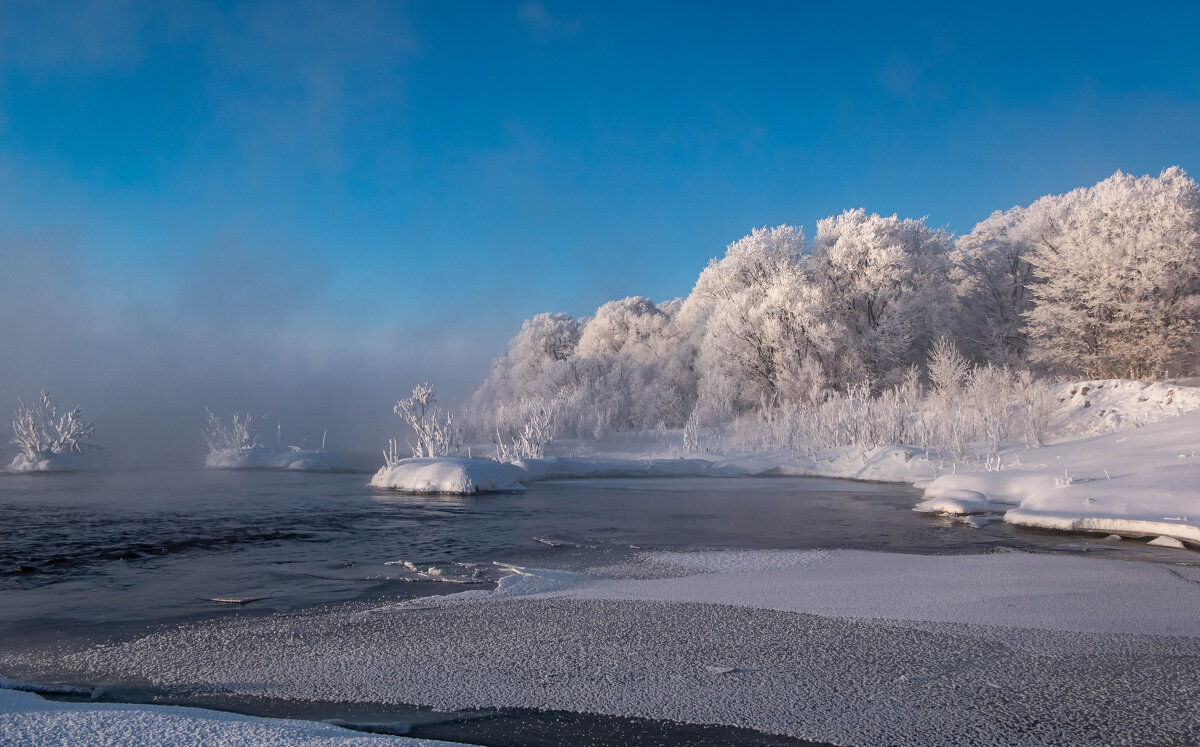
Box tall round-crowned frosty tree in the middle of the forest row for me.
[810,209,952,387]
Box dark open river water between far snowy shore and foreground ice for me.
[0,471,1190,644]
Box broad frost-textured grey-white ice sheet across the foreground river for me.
[9,551,1200,745]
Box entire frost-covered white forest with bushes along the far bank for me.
[466,167,1200,456]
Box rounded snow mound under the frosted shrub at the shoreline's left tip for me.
[371,456,529,495]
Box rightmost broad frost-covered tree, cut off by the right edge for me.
[1025,167,1200,378]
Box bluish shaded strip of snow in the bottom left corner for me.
[0,688,450,747]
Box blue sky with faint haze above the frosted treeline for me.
[0,0,1200,458]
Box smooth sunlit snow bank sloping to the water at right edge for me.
[917,411,1200,544]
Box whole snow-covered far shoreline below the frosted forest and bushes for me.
[371,381,1200,544]
